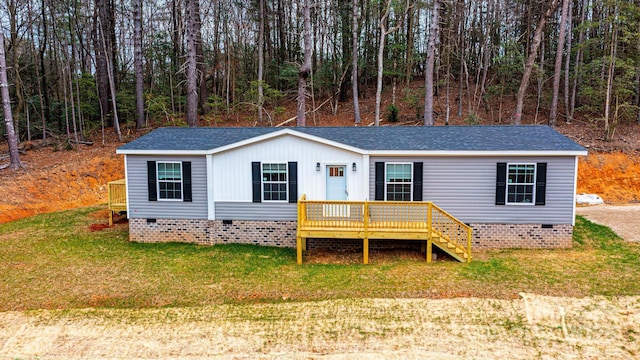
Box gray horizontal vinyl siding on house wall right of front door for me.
[369,156,575,224]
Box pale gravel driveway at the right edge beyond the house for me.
[576,205,640,243]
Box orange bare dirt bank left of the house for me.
[0,135,124,223]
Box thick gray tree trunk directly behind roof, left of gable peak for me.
[186,0,199,127]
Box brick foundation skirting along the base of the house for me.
[129,219,573,250]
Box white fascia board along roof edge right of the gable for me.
[368,150,587,156]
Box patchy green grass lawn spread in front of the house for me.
[0,208,640,311]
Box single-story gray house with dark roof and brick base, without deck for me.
[117,125,587,253]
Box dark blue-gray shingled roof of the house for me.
[118,125,585,152]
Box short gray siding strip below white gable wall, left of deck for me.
[215,202,298,220]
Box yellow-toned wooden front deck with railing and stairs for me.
[296,195,472,264]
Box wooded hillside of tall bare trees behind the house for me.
[0,0,640,142]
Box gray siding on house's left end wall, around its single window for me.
[127,155,207,220]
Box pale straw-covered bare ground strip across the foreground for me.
[0,294,640,359]
